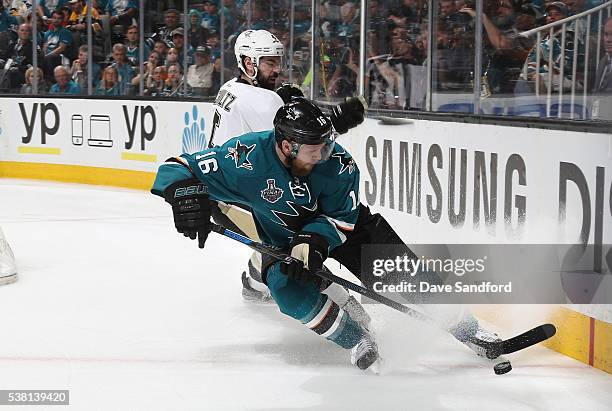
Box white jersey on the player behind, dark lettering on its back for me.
[208,78,283,147]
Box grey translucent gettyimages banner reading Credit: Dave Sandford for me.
[361,244,612,304]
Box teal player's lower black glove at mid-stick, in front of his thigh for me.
[281,231,329,284]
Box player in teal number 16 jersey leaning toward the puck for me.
[152,98,506,369]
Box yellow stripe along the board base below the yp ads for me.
[0,161,155,190]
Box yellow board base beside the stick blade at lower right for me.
[543,307,612,373]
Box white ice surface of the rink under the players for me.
[0,180,612,411]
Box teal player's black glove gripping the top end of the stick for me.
[164,178,211,248]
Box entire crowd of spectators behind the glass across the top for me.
[0,0,612,109]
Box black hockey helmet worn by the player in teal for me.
[274,97,333,145]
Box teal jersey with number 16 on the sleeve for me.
[151,131,359,251]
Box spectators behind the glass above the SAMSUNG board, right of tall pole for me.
[358,0,612,109]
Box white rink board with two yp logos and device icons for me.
[0,98,218,172]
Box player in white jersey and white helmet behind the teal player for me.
[208,30,370,318]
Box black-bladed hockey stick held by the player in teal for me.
[211,223,556,359]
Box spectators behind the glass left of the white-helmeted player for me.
[0,0,229,97]
